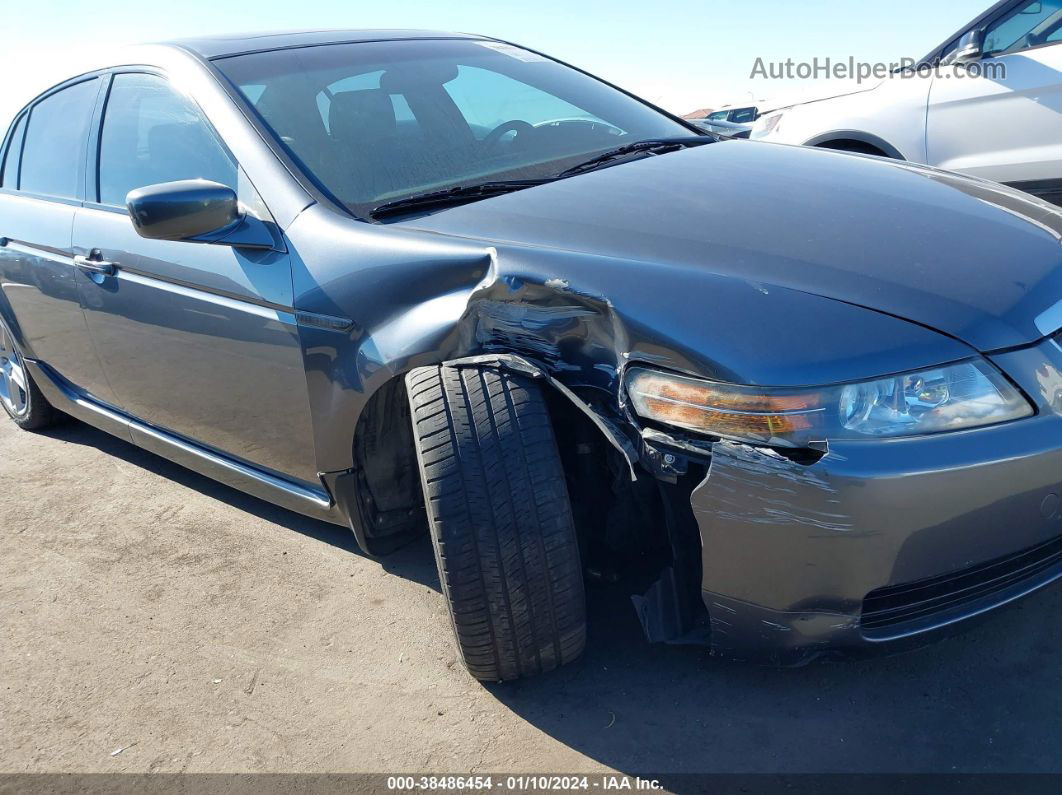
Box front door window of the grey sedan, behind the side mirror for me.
[100,74,237,206]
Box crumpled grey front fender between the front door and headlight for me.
[286,206,970,471]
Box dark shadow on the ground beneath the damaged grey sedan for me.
[37,422,1062,776]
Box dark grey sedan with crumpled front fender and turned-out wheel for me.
[0,31,1062,680]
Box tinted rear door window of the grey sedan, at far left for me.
[19,77,100,198]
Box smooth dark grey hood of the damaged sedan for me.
[398,141,1062,351]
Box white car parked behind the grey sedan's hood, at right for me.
[752,0,1062,204]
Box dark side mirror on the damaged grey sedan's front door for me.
[125,179,240,240]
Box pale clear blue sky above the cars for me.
[0,0,991,124]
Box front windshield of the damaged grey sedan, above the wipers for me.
[215,39,690,217]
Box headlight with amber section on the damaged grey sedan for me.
[626,360,1033,447]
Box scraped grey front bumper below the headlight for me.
[690,340,1062,664]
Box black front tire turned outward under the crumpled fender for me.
[406,367,586,681]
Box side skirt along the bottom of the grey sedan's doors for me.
[25,359,349,526]
